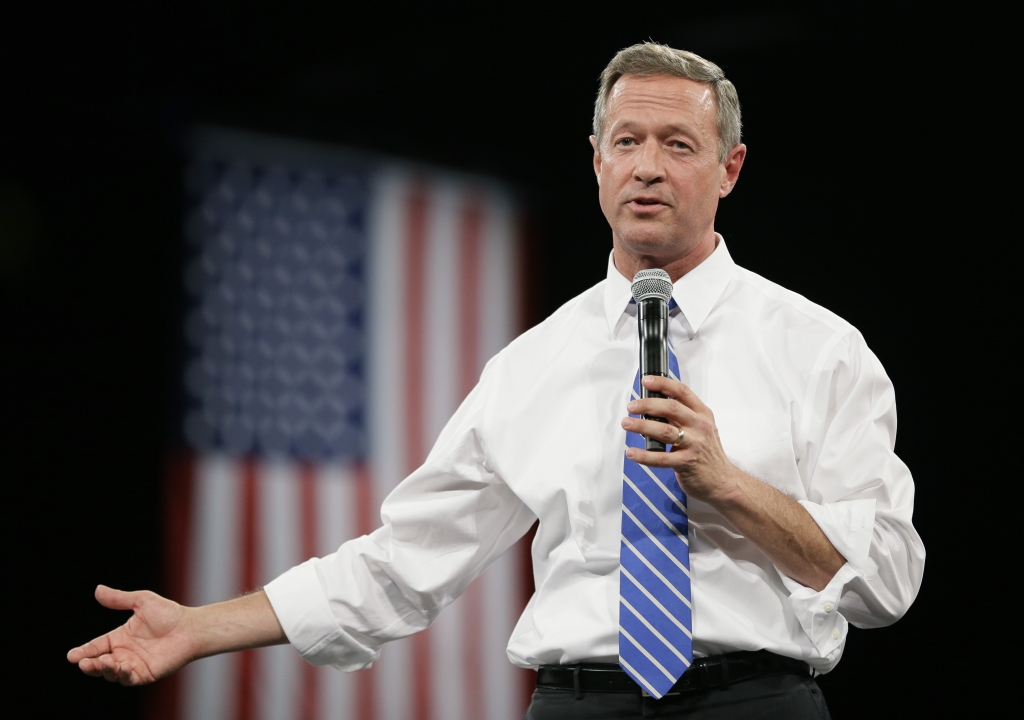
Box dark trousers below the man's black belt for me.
[523,675,830,720]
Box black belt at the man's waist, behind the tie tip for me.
[537,650,811,697]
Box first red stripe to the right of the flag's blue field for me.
[404,179,433,720]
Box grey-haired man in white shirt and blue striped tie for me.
[69,43,925,718]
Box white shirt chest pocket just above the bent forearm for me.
[715,413,806,500]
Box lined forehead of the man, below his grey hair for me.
[605,75,717,132]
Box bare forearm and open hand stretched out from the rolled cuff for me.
[68,585,288,685]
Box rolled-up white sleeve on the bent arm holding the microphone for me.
[783,331,925,660]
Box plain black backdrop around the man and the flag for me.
[6,3,1019,718]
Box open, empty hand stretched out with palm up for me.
[68,585,197,685]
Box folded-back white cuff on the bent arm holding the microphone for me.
[779,500,878,670]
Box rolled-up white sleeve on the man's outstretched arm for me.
[264,362,537,671]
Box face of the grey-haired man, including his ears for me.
[591,75,745,260]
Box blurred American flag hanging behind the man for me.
[155,129,529,720]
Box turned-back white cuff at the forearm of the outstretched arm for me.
[263,558,380,672]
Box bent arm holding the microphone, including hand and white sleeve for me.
[623,333,925,627]
